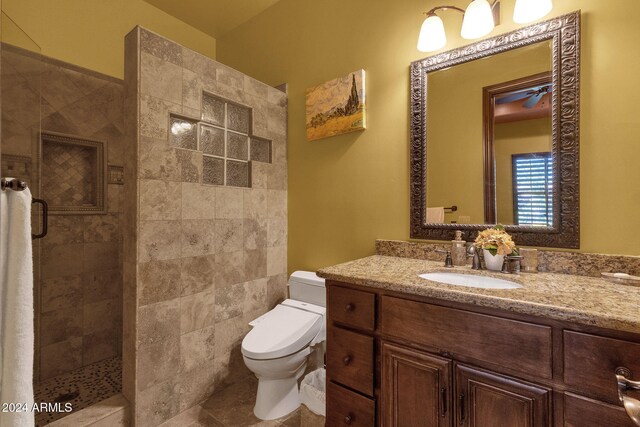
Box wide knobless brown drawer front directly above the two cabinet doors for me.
[380,296,552,378]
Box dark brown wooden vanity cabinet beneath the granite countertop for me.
[327,280,640,427]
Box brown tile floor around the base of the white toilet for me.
[161,378,320,427]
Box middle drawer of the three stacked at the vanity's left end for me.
[327,327,374,396]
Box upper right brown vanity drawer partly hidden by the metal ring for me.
[563,330,640,403]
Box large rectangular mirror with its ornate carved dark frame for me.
[410,11,580,248]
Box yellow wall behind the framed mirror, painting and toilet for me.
[217,0,640,270]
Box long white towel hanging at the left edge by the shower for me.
[0,189,35,427]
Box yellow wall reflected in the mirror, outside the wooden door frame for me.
[427,41,552,224]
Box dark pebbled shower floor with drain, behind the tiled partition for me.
[34,357,122,427]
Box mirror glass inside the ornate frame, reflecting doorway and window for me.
[426,40,554,226]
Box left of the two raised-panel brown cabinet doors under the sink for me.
[380,343,452,427]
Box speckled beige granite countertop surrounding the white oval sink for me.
[318,255,640,333]
